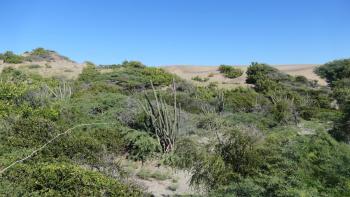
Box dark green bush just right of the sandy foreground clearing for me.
[191,128,260,191]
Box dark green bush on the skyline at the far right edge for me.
[315,59,350,85]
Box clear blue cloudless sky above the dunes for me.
[0,0,350,66]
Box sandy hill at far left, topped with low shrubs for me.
[0,50,85,79]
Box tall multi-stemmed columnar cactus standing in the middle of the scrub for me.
[141,80,180,153]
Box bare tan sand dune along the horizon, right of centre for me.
[163,64,326,88]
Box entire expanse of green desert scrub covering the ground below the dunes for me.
[0,48,350,196]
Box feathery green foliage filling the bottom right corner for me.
[255,131,350,196]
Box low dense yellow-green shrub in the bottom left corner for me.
[0,163,141,196]
